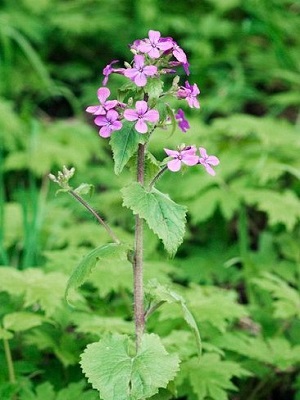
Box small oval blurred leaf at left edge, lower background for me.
[3,311,46,332]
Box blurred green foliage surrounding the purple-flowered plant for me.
[0,0,300,400]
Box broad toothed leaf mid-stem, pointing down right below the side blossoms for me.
[121,183,186,255]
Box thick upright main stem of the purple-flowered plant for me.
[133,144,145,350]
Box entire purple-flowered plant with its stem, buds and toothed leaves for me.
[50,30,219,400]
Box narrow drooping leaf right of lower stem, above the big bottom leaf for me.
[148,280,202,356]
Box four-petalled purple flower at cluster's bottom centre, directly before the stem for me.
[124,100,159,133]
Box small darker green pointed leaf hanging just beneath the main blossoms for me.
[110,121,144,175]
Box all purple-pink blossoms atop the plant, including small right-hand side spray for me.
[86,30,219,175]
